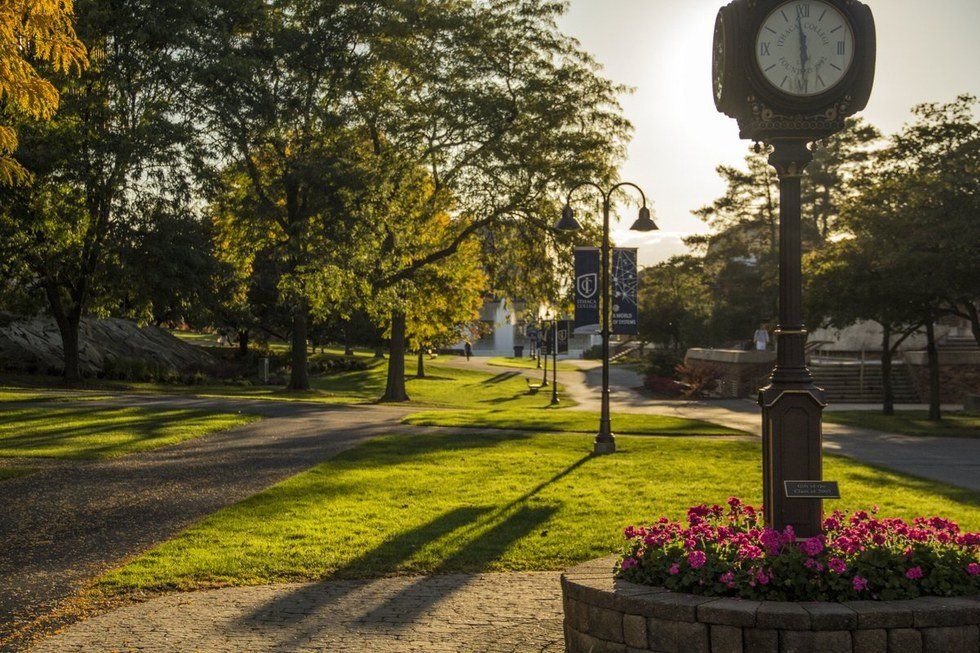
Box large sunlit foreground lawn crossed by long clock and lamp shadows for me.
[99,432,980,593]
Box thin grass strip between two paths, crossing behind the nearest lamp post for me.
[404,408,749,435]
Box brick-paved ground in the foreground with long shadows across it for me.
[36,572,564,653]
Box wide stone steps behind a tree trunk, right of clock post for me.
[809,361,919,404]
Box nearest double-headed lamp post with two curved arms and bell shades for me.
[555,181,657,455]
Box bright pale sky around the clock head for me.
[560,0,980,265]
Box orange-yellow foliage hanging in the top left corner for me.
[0,0,88,184]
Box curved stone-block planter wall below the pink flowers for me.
[562,558,980,653]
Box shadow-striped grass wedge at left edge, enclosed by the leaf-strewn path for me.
[0,405,257,458]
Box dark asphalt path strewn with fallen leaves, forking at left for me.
[0,396,409,649]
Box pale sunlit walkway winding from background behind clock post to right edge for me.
[440,358,980,492]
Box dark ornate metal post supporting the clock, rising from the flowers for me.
[759,140,826,537]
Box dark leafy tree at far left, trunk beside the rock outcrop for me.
[0,0,195,380]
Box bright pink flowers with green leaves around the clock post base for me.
[617,497,980,601]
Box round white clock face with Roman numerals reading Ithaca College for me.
[755,0,854,97]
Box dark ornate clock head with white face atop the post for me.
[712,0,875,142]
